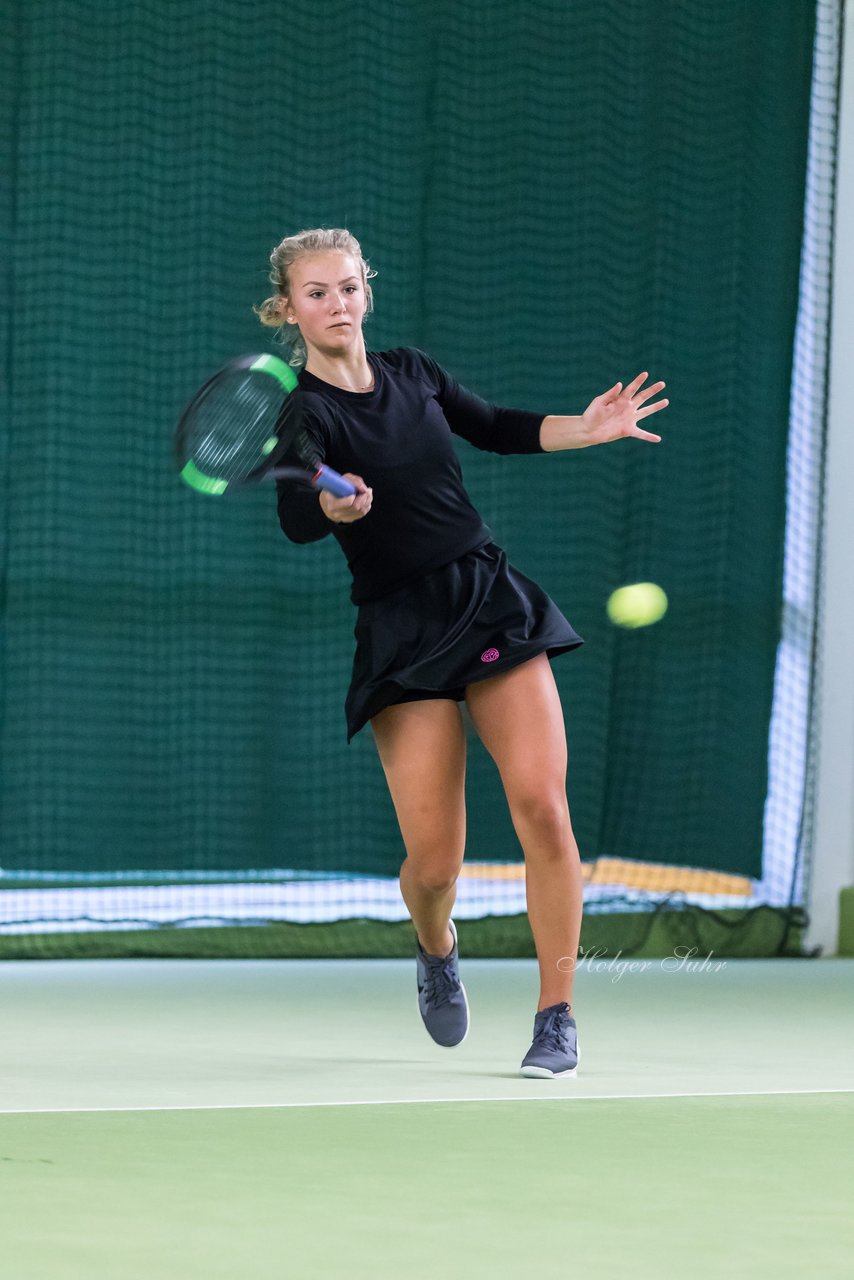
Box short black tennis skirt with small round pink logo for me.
[344,543,584,742]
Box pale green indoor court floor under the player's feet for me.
[0,957,854,1280]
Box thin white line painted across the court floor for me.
[0,1088,854,1116]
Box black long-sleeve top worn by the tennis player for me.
[277,347,543,604]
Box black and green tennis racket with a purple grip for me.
[175,355,356,498]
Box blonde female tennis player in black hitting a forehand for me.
[257,229,668,1078]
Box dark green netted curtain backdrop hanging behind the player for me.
[0,0,829,957]
